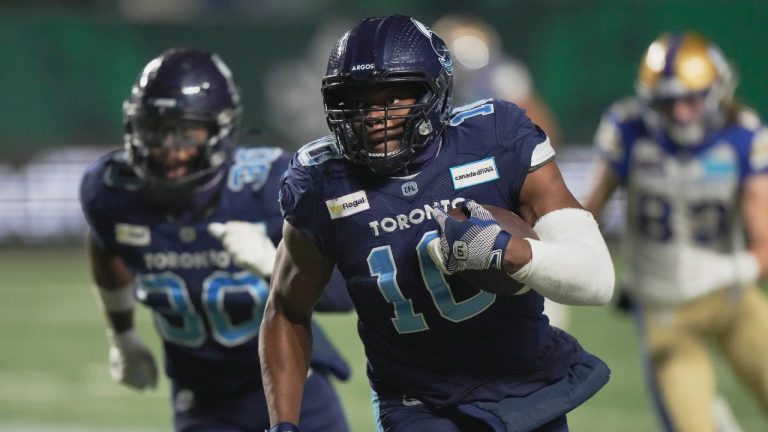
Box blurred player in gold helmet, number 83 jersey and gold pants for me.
[586,32,768,432]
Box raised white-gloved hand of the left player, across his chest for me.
[208,221,277,277]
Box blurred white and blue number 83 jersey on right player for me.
[596,99,768,305]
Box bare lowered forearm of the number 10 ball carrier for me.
[259,293,312,425]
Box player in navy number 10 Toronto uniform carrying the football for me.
[250,15,614,432]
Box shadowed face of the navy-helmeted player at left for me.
[142,121,210,181]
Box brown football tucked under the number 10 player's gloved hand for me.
[448,204,539,295]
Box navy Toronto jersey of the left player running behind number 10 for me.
[80,148,348,393]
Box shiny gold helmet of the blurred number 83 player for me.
[635,32,736,144]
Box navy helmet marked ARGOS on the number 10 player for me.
[322,15,453,175]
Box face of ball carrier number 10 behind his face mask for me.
[351,85,417,154]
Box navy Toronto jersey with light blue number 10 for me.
[280,100,582,405]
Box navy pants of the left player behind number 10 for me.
[173,373,349,432]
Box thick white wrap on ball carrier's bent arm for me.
[510,208,616,305]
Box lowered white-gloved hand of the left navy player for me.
[107,329,157,390]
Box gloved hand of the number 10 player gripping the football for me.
[427,200,510,274]
